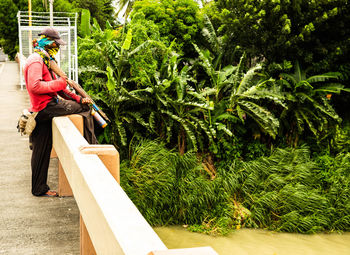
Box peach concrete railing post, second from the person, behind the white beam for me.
[80,145,120,255]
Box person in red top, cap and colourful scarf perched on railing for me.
[24,28,97,196]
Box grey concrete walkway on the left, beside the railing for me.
[0,62,79,255]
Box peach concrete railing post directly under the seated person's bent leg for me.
[57,114,84,197]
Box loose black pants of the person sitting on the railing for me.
[31,99,97,196]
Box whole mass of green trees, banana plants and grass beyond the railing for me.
[79,0,350,234]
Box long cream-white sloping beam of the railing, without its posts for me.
[53,117,167,255]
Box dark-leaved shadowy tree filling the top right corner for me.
[217,0,350,73]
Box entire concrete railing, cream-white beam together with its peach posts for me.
[53,115,217,255]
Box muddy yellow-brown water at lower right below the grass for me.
[154,227,350,255]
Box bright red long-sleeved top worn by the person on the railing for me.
[23,53,81,112]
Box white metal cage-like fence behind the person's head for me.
[17,11,78,89]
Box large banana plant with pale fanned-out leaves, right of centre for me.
[194,44,286,138]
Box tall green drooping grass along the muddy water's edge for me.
[121,140,350,234]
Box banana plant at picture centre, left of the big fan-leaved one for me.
[150,52,213,155]
